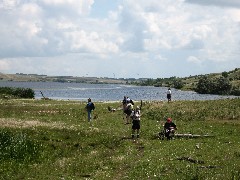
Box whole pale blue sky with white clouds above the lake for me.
[0,0,240,78]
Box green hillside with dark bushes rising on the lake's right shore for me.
[133,68,240,96]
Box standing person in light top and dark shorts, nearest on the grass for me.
[131,106,141,138]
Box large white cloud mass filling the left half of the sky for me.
[0,0,118,58]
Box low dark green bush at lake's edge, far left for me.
[0,87,35,98]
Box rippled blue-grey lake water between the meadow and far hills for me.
[0,81,234,101]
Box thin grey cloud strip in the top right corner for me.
[186,0,240,8]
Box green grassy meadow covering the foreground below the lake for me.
[0,99,240,180]
